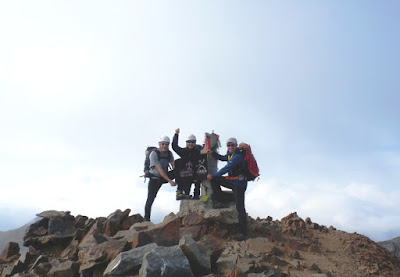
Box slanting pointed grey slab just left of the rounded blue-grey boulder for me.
[104,243,157,276]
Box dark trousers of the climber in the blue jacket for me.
[211,178,247,236]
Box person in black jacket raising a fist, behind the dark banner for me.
[172,128,201,200]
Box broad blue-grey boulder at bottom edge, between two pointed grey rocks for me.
[139,245,194,277]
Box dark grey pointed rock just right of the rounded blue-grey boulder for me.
[179,237,211,276]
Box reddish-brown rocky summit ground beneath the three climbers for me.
[0,200,400,277]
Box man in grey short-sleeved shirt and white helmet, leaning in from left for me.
[144,136,176,221]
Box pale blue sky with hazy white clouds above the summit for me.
[0,0,400,241]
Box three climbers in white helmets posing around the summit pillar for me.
[144,128,260,240]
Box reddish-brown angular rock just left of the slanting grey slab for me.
[78,240,127,271]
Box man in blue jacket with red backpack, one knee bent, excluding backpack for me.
[207,138,247,240]
